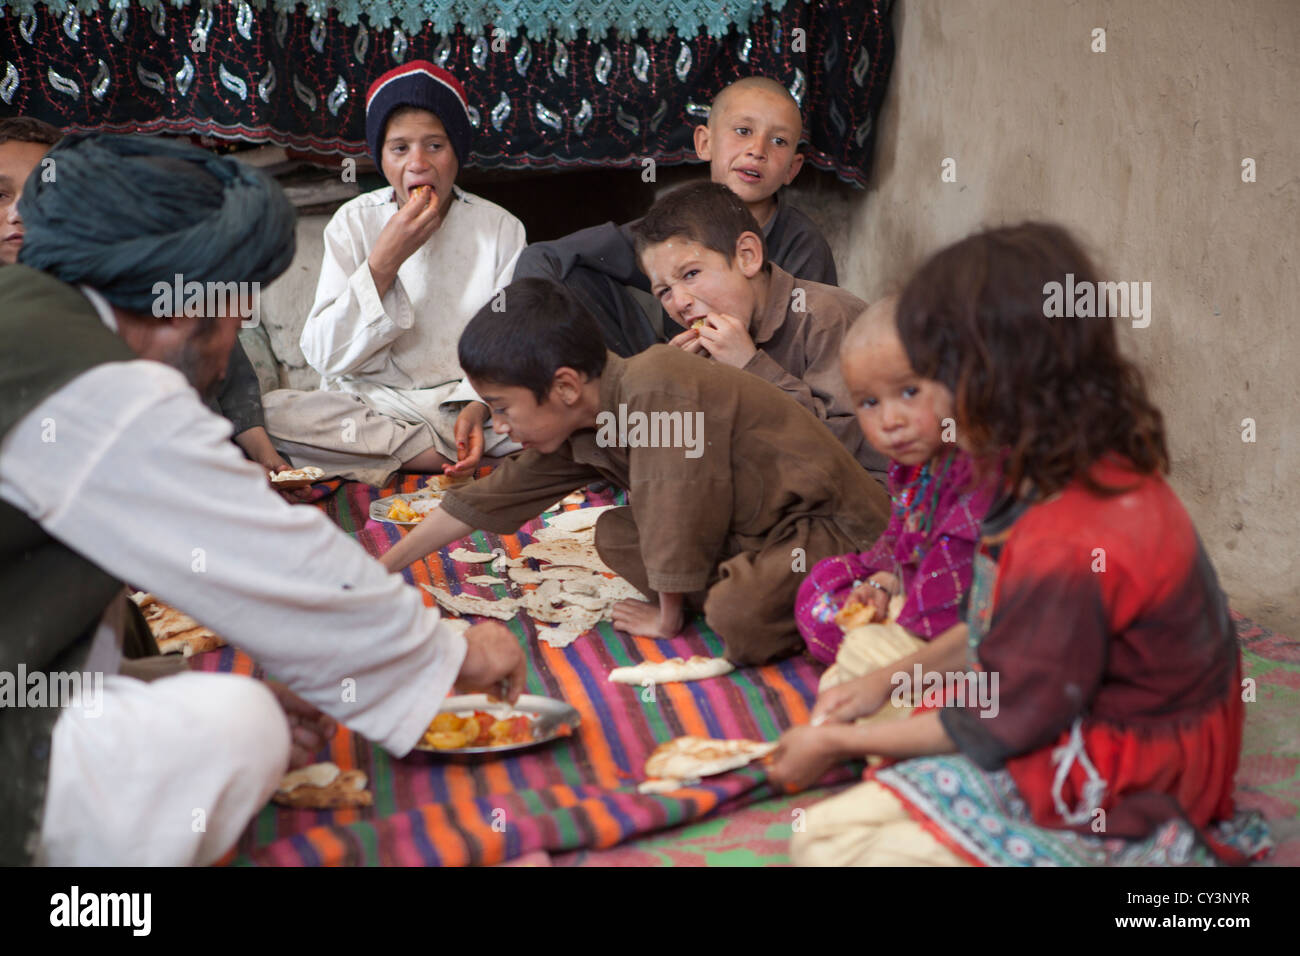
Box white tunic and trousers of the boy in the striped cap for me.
[263,187,527,484]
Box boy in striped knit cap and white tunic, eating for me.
[263,60,525,485]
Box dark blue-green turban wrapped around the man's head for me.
[18,133,295,315]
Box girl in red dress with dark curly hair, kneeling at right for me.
[772,224,1269,865]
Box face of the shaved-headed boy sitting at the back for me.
[696,88,803,203]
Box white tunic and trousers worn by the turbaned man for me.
[0,293,465,865]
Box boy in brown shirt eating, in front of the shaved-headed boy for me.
[632,182,889,481]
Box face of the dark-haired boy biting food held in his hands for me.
[641,233,763,326]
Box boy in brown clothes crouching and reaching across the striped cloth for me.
[382,278,889,665]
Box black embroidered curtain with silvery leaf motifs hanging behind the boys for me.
[0,0,894,185]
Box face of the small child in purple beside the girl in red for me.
[840,336,959,464]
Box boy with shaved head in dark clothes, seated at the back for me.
[515,77,837,356]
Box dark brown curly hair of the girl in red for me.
[897,222,1169,497]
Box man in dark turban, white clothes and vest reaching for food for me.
[0,135,525,865]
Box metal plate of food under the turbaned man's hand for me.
[413,693,582,757]
